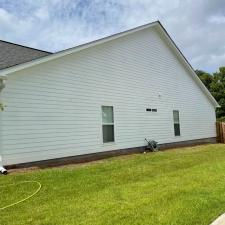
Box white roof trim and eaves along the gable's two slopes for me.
[0,21,220,107]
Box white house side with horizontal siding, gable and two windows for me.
[0,21,218,168]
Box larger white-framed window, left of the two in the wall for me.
[102,106,114,143]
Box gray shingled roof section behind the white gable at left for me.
[0,40,52,70]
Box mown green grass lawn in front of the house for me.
[0,144,225,225]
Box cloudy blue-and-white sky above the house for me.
[0,0,225,72]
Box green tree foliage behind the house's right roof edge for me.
[196,67,225,118]
